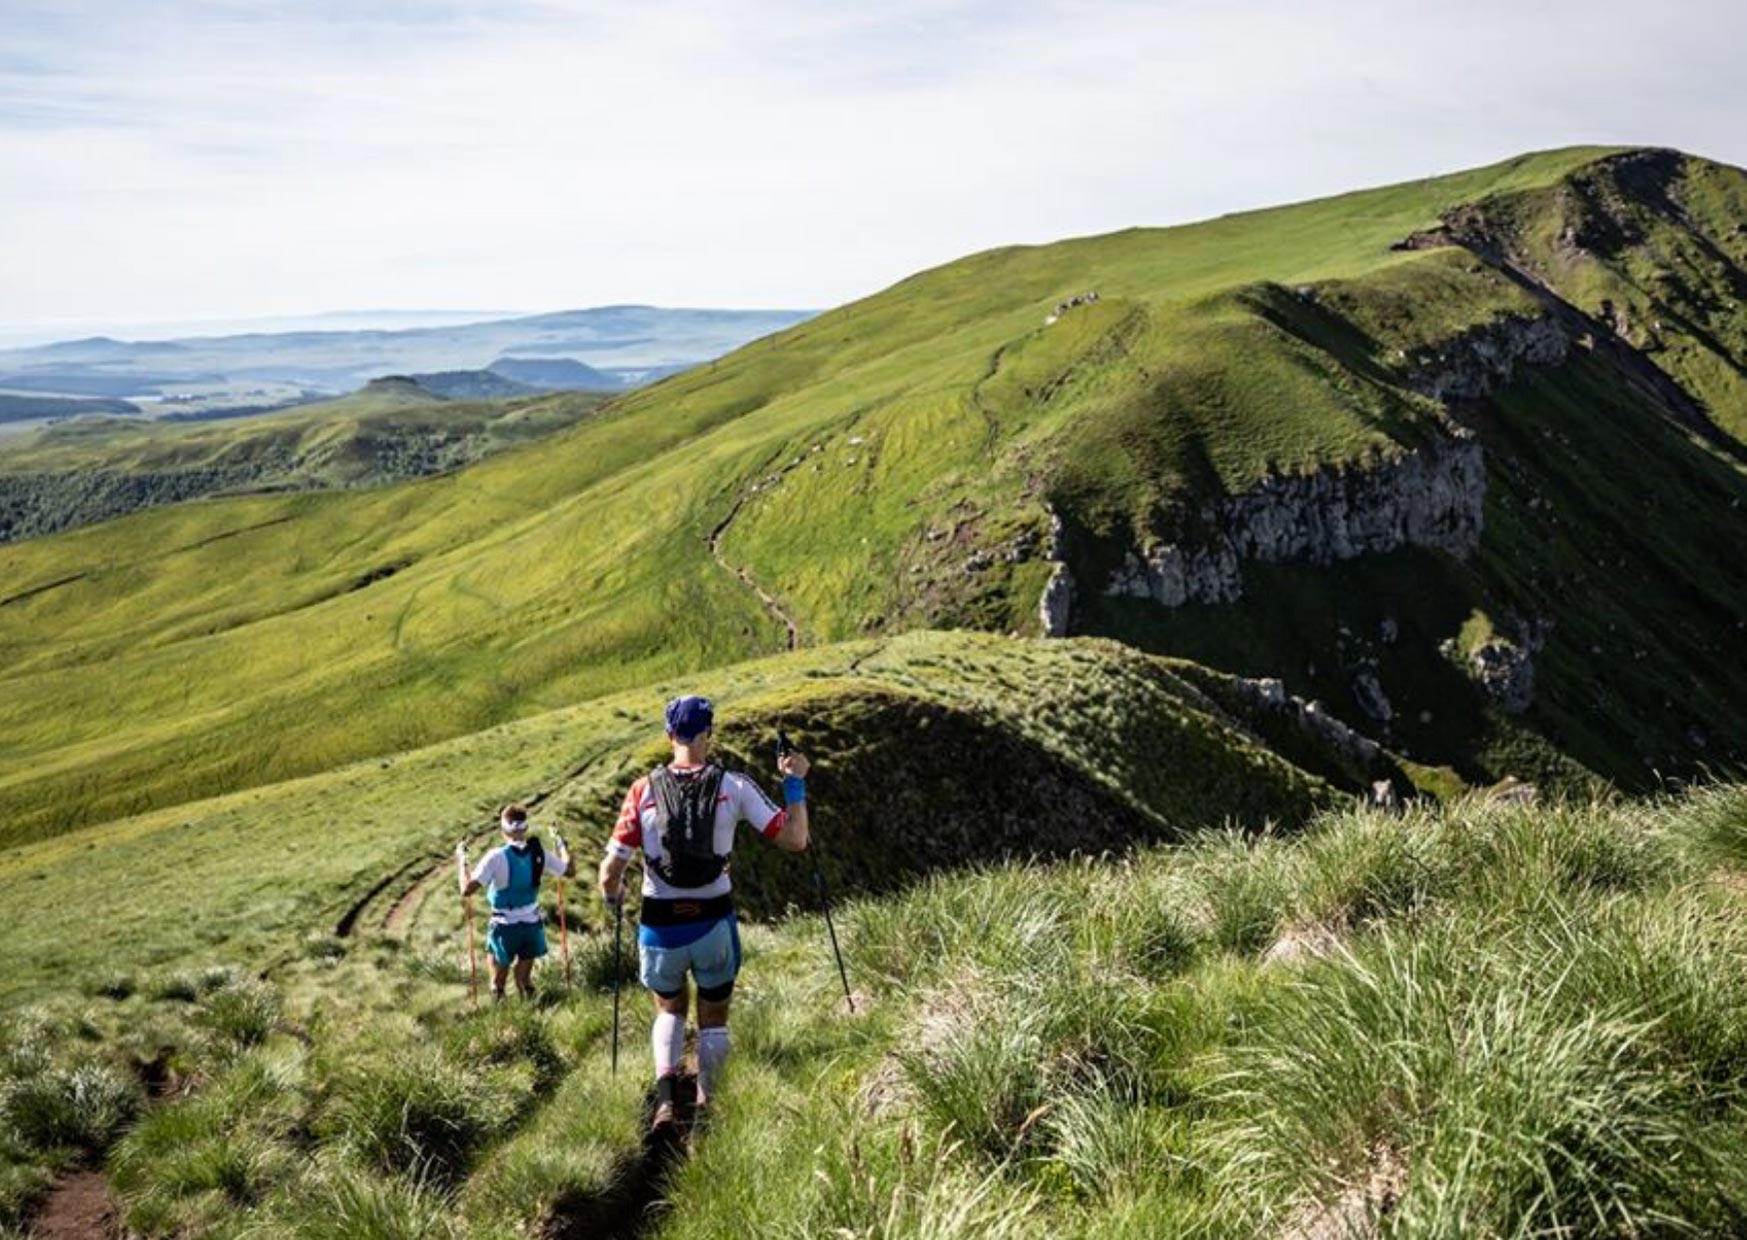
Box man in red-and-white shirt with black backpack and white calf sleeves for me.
[601,697,807,1128]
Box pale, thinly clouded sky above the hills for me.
[0,0,1747,333]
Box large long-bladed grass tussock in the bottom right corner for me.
[1212,919,1747,1235]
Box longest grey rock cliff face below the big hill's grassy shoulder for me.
[1108,431,1487,608]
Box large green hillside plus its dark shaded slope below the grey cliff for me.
[0,148,1747,845]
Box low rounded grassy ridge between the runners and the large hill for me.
[0,634,1338,1001]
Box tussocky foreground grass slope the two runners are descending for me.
[13,789,1747,1240]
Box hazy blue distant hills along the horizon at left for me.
[0,306,812,407]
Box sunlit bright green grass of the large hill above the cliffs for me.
[0,148,1698,838]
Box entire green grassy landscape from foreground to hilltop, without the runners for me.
[0,147,1747,1240]
